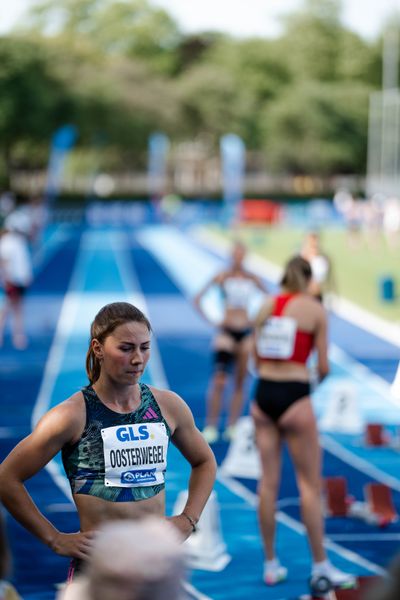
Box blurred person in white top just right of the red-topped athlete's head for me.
[301,231,335,302]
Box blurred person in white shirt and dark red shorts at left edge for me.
[0,211,33,350]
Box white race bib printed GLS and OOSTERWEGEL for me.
[101,423,168,487]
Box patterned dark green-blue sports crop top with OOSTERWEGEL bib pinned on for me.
[61,383,171,502]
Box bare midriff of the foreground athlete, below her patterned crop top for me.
[74,490,165,531]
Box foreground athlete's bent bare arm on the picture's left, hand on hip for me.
[0,395,92,559]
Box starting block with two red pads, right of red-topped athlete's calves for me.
[324,477,398,527]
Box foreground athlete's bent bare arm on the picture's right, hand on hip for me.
[168,392,217,537]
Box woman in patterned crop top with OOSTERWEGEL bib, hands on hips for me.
[0,302,216,576]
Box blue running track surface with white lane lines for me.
[0,220,400,600]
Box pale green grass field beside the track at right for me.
[206,226,400,324]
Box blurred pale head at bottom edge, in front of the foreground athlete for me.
[58,516,185,600]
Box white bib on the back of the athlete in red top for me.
[256,317,297,359]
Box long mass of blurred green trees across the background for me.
[0,0,390,185]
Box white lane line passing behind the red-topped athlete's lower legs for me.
[217,474,386,575]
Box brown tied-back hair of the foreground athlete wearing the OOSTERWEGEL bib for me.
[86,302,151,385]
